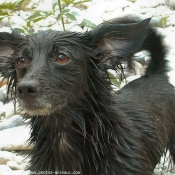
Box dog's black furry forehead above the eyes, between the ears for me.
[22,30,90,58]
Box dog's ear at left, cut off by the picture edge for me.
[0,32,22,78]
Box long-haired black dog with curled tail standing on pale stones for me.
[0,16,175,175]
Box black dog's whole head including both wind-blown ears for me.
[0,19,150,115]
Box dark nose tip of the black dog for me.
[17,81,38,98]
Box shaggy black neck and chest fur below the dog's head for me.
[30,72,116,172]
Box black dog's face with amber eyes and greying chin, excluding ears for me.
[14,31,91,115]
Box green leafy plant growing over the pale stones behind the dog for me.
[0,0,96,33]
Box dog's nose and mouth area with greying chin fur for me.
[17,80,68,116]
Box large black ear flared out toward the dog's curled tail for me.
[91,19,150,68]
